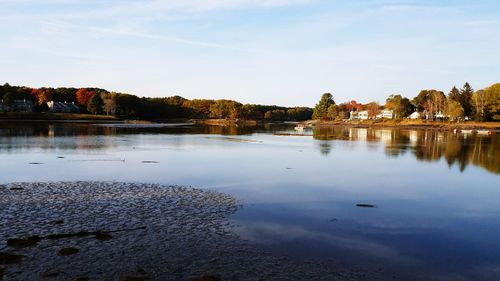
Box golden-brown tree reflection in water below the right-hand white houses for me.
[313,126,500,174]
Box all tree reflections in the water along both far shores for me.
[0,124,500,174]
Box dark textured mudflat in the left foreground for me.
[0,181,373,281]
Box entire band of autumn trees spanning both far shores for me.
[0,83,500,121]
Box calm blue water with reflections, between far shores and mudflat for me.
[0,124,500,280]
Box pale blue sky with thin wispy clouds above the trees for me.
[0,0,500,106]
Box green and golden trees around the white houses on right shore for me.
[313,83,500,121]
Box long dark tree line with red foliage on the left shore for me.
[0,84,312,121]
